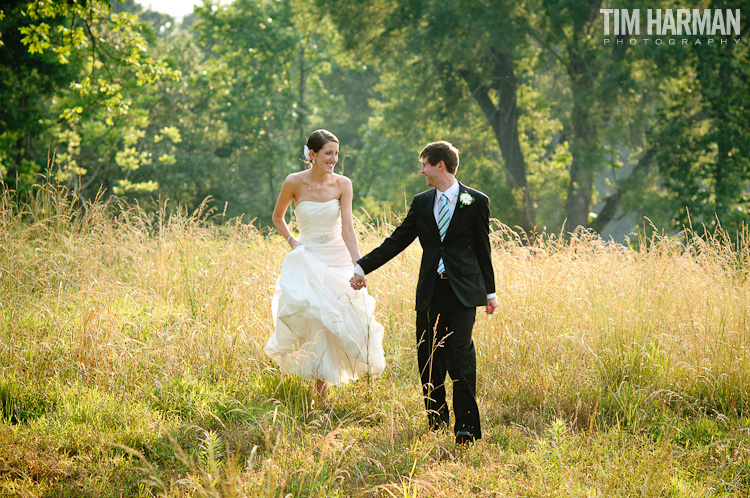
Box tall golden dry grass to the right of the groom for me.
[477,226,750,427]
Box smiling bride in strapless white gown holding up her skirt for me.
[264,130,385,406]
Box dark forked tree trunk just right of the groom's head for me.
[460,48,536,236]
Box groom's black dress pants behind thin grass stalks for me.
[417,279,482,439]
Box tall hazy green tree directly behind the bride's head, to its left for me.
[182,0,338,220]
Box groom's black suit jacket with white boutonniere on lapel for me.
[358,182,495,310]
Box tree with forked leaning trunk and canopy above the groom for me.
[318,0,536,233]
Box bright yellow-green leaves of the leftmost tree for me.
[0,0,179,199]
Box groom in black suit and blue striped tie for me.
[351,141,497,444]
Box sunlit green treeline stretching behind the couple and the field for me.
[0,0,750,237]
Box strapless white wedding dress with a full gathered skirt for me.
[264,199,385,386]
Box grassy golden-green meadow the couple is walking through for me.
[0,187,750,498]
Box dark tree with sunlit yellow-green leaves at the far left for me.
[0,0,179,198]
